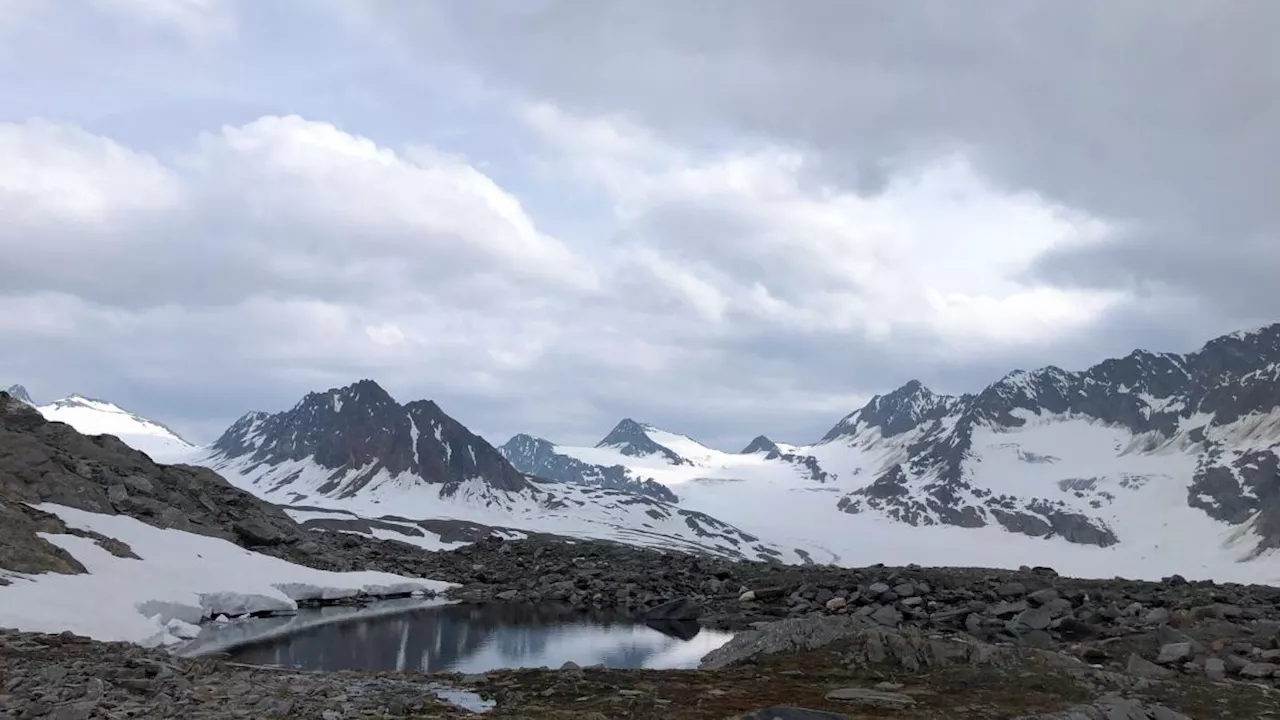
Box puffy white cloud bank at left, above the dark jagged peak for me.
[0,117,594,306]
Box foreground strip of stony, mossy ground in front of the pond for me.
[0,584,1280,720]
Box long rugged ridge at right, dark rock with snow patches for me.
[823,325,1280,559]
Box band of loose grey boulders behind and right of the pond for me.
[425,538,1280,684]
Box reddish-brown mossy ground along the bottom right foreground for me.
[453,638,1280,720]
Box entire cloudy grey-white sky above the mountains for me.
[0,0,1280,450]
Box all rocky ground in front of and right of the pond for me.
[12,536,1280,720]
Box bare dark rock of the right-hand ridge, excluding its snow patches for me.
[823,324,1280,552]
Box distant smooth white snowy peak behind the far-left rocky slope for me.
[8,384,196,462]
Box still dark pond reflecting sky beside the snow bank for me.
[193,603,731,673]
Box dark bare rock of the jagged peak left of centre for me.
[214,380,529,498]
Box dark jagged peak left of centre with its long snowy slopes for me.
[191,380,799,560]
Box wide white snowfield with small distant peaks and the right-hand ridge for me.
[499,324,1280,580]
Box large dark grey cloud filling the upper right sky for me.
[364,0,1280,343]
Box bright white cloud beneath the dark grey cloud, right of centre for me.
[524,104,1124,351]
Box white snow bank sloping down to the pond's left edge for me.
[0,503,452,646]
